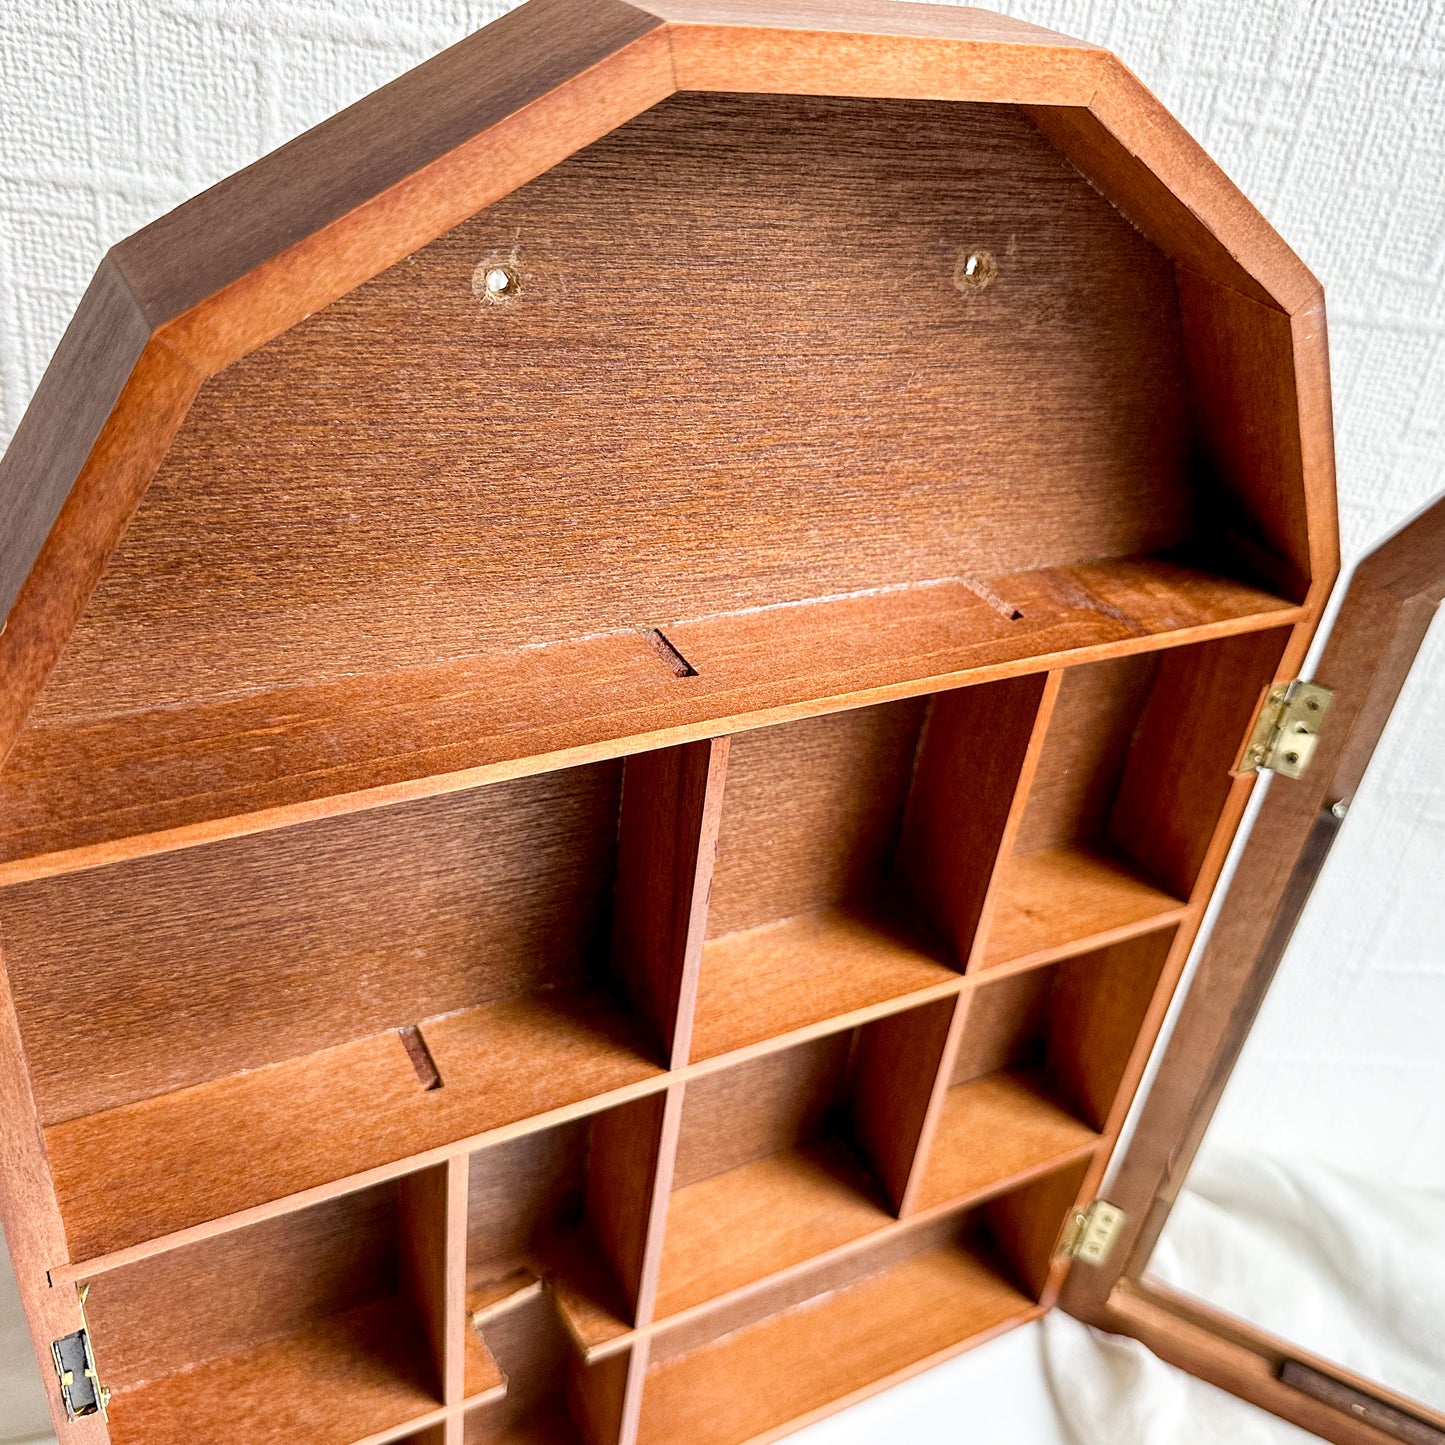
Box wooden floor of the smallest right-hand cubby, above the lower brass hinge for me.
[916,1069,1100,1211]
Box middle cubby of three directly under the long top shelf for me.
[692,675,1043,1059]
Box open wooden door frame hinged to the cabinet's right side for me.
[1059,496,1445,1445]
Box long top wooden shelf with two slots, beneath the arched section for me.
[0,556,1301,883]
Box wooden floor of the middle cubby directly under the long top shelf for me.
[692,909,958,1059]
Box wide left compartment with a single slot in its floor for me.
[12,762,676,1260]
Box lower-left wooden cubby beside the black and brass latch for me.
[77,1165,473,1445]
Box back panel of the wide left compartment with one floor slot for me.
[0,763,621,1124]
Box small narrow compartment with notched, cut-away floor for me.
[467,1094,665,1355]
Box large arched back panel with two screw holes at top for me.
[35,95,1191,724]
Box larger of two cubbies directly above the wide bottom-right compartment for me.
[656,998,954,1319]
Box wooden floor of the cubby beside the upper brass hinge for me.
[981,844,1188,968]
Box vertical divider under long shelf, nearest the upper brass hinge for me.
[897,673,1059,968]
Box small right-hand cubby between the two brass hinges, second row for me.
[916,928,1173,1209]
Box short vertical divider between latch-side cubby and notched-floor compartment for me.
[397,1155,467,1405]
